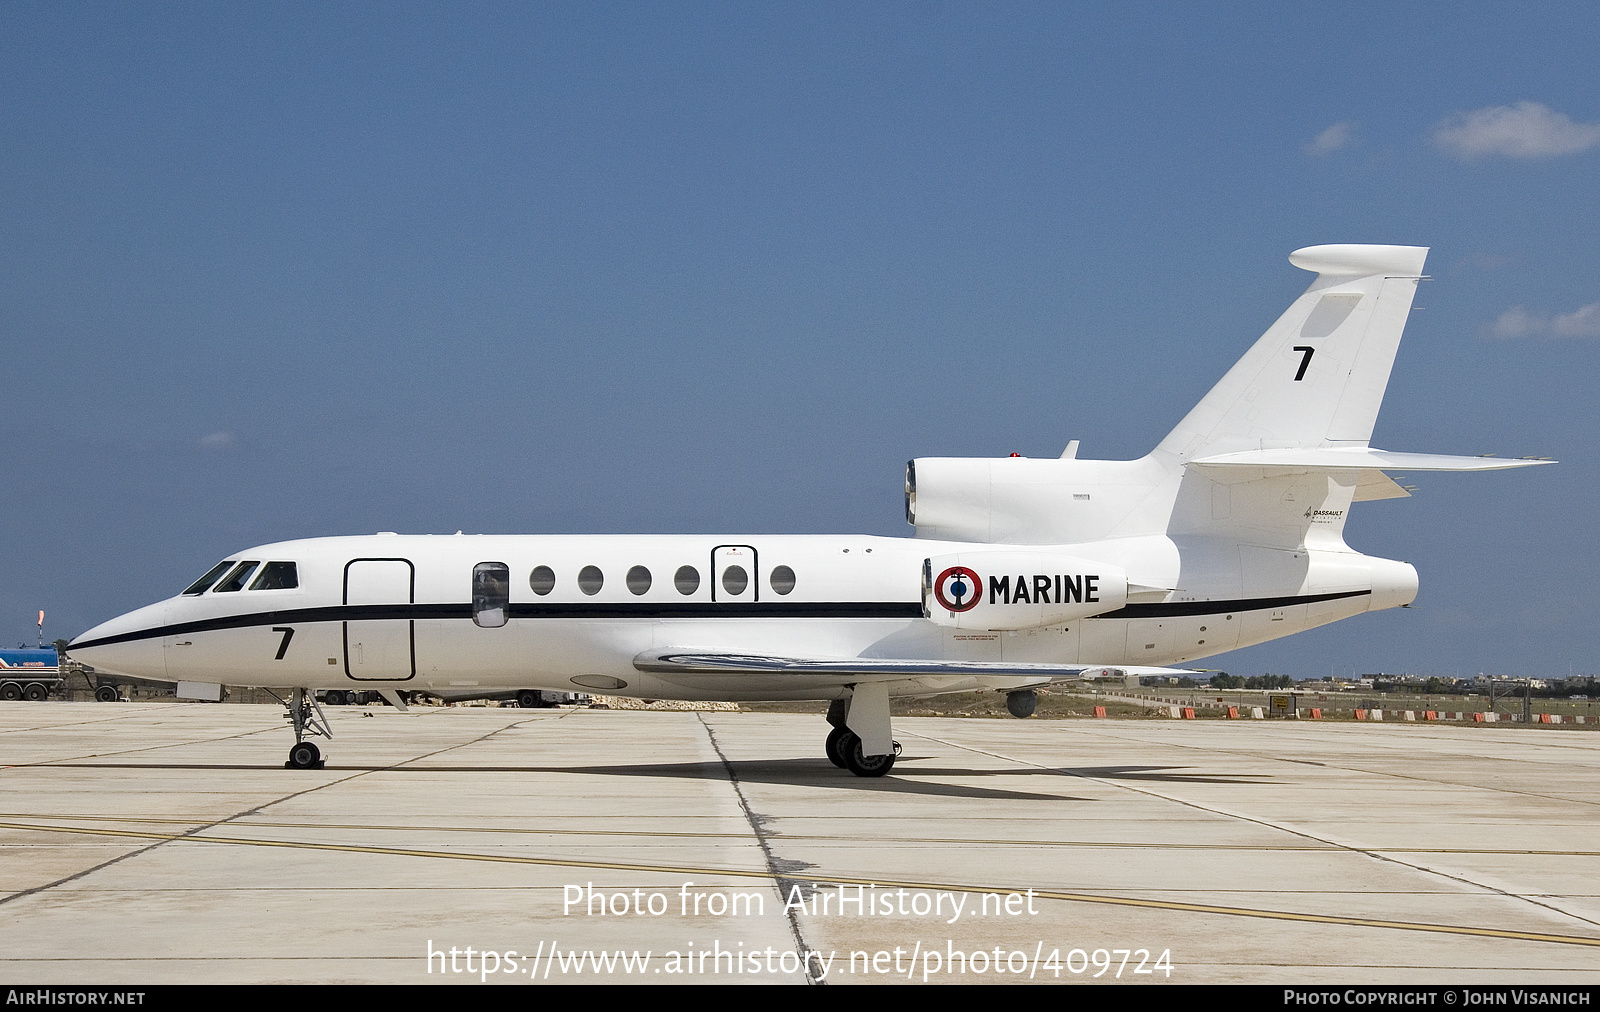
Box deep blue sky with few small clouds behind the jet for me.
[0,3,1600,676]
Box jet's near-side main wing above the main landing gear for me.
[634,650,1200,689]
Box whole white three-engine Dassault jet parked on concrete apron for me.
[67,245,1547,777]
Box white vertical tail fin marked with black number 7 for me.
[1157,245,1427,461]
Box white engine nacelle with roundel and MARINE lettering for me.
[922,551,1128,629]
